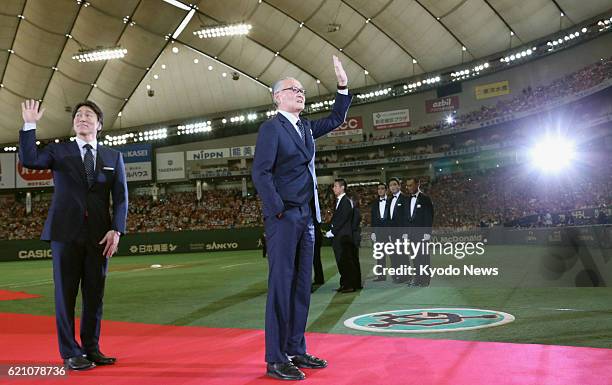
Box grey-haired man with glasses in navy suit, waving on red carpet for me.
[252,56,351,380]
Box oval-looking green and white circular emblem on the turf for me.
[344,307,514,333]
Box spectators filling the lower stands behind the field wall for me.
[0,163,612,239]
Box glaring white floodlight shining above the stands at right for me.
[531,137,576,172]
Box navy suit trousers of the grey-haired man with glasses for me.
[264,204,314,362]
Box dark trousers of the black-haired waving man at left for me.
[51,229,108,358]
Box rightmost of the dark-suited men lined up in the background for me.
[406,178,434,286]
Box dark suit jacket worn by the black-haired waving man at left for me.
[19,130,128,242]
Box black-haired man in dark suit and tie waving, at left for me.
[19,100,128,370]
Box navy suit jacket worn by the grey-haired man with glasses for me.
[251,93,352,217]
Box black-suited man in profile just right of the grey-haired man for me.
[326,179,361,293]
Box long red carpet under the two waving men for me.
[0,313,612,385]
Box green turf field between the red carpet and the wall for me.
[0,246,612,348]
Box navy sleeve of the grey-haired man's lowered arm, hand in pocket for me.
[251,123,285,217]
